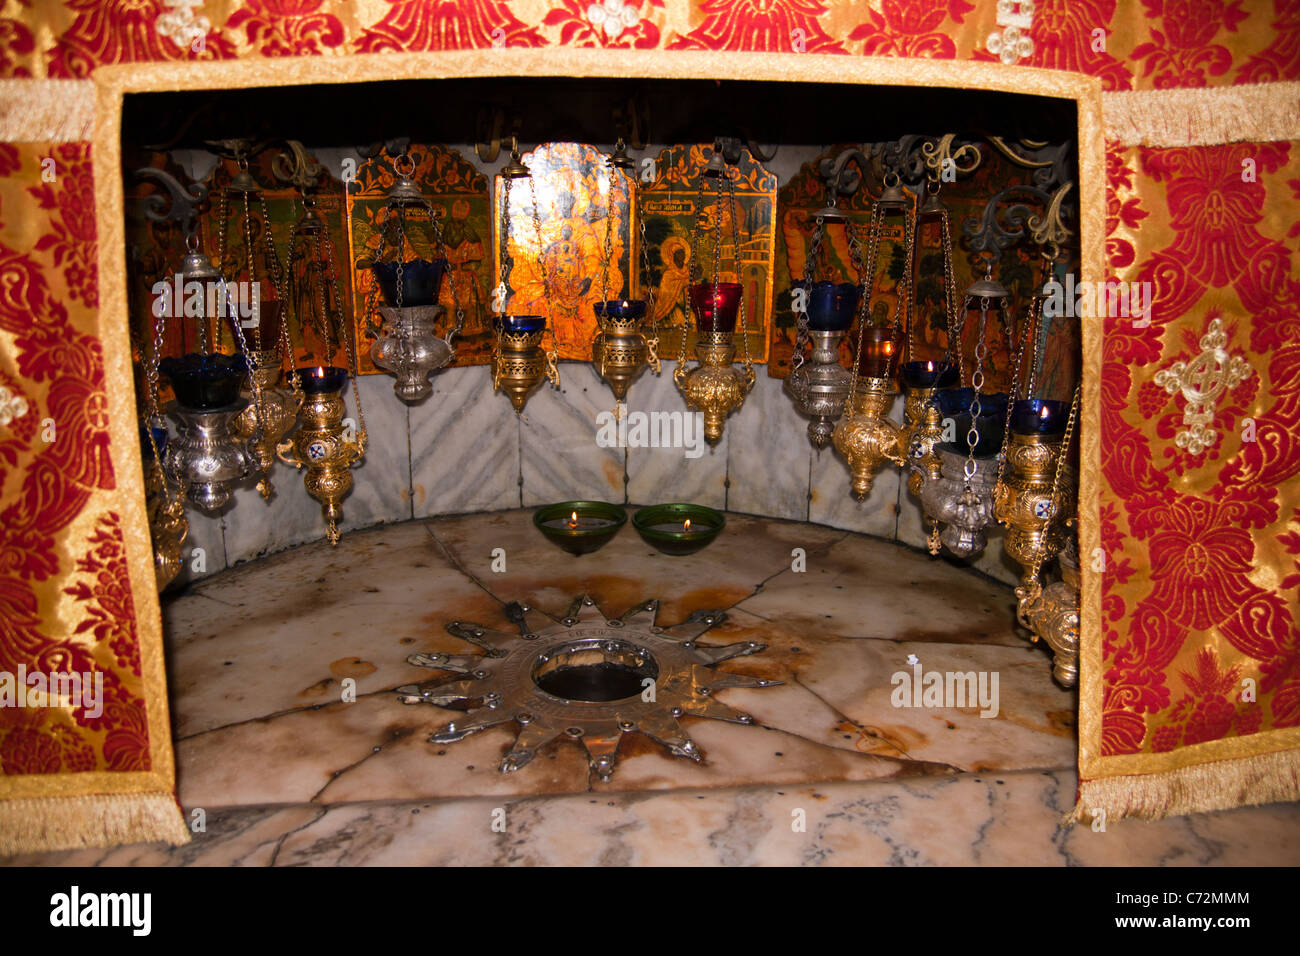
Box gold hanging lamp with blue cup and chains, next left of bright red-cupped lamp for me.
[592,139,659,402]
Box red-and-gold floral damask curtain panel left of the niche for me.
[0,143,172,796]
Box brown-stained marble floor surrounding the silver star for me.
[0,511,1300,865]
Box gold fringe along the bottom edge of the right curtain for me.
[1061,750,1300,826]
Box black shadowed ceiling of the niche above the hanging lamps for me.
[122,77,1075,148]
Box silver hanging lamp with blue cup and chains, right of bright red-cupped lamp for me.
[785,197,863,449]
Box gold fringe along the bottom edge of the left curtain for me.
[0,793,190,856]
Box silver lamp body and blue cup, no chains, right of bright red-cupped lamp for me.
[785,282,862,449]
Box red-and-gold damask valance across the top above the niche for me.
[0,0,1300,90]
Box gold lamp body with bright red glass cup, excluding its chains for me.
[672,280,754,445]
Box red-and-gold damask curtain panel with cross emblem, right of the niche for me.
[1082,142,1300,801]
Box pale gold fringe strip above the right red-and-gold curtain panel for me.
[1101,82,1300,147]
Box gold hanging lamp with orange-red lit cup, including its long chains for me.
[832,172,915,501]
